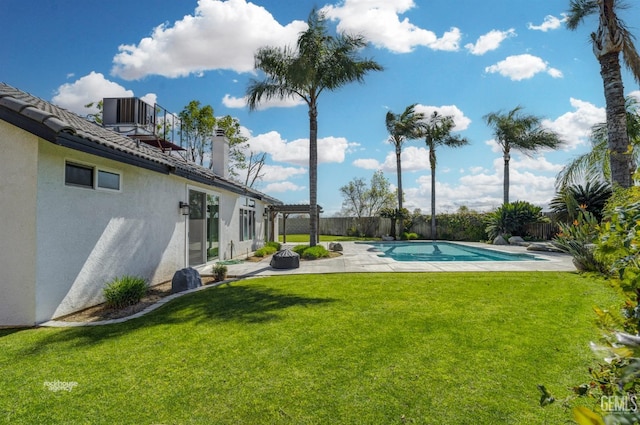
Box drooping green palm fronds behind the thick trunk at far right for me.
[556,96,640,190]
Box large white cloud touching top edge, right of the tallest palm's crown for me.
[322,0,461,53]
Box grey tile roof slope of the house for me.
[0,82,282,204]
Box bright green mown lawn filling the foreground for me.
[0,272,621,425]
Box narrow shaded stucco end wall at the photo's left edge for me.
[0,121,38,326]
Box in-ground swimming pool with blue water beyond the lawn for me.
[358,241,545,261]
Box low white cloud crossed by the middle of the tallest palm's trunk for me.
[249,131,354,166]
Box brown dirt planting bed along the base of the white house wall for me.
[55,276,214,322]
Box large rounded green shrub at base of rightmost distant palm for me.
[486,201,549,240]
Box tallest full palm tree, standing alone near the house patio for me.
[247,9,382,246]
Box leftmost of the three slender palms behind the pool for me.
[385,103,424,237]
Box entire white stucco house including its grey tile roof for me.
[0,83,279,327]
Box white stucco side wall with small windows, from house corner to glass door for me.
[36,141,186,322]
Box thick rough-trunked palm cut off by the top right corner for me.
[567,0,640,187]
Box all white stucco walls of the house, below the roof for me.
[0,121,277,326]
